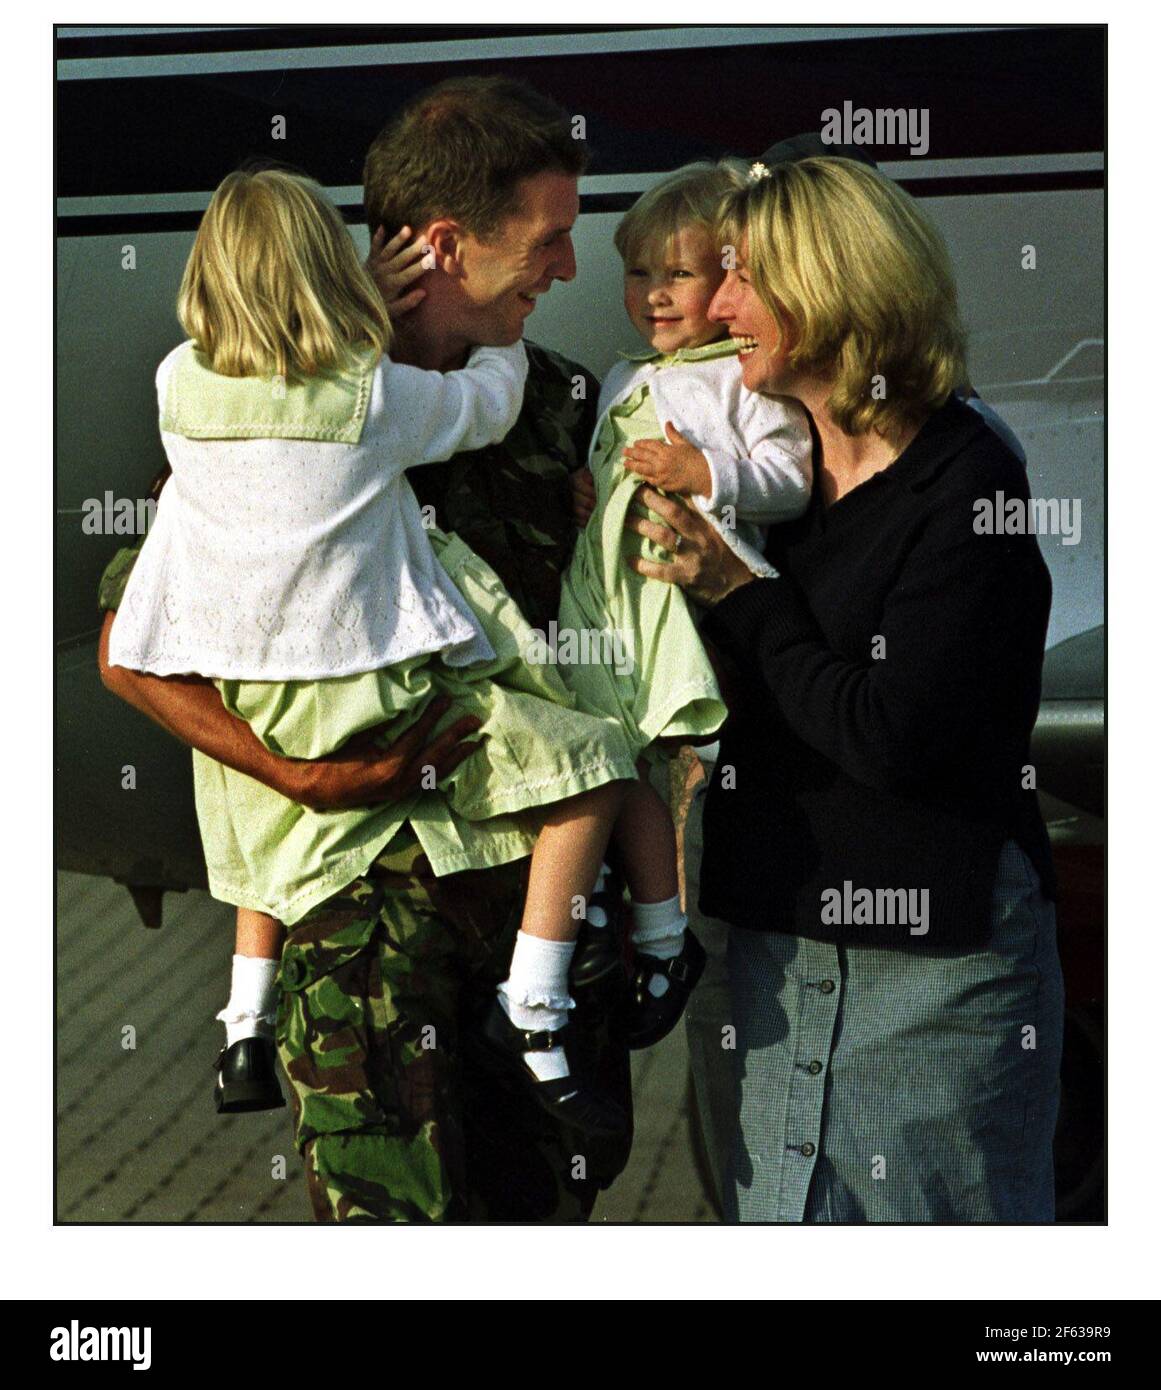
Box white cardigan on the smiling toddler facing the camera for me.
[594,345,812,569]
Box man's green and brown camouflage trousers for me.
[277,831,631,1222]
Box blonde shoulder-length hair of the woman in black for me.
[720,157,966,438]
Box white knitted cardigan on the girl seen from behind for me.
[108,343,528,681]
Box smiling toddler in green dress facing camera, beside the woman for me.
[558,161,811,1047]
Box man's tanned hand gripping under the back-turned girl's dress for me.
[297,696,480,810]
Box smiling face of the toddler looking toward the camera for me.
[624,225,724,353]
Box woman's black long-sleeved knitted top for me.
[699,399,1055,951]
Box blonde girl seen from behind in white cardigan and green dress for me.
[108,170,689,1136]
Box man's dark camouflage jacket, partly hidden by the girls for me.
[97,342,599,628]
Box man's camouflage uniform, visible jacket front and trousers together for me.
[269,333,631,1220]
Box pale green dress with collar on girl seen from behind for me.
[146,347,637,926]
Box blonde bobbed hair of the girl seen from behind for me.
[178,168,391,378]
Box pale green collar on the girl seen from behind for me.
[161,345,378,443]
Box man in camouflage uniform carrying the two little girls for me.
[102,79,631,1222]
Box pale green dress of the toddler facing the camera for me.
[559,345,733,760]
